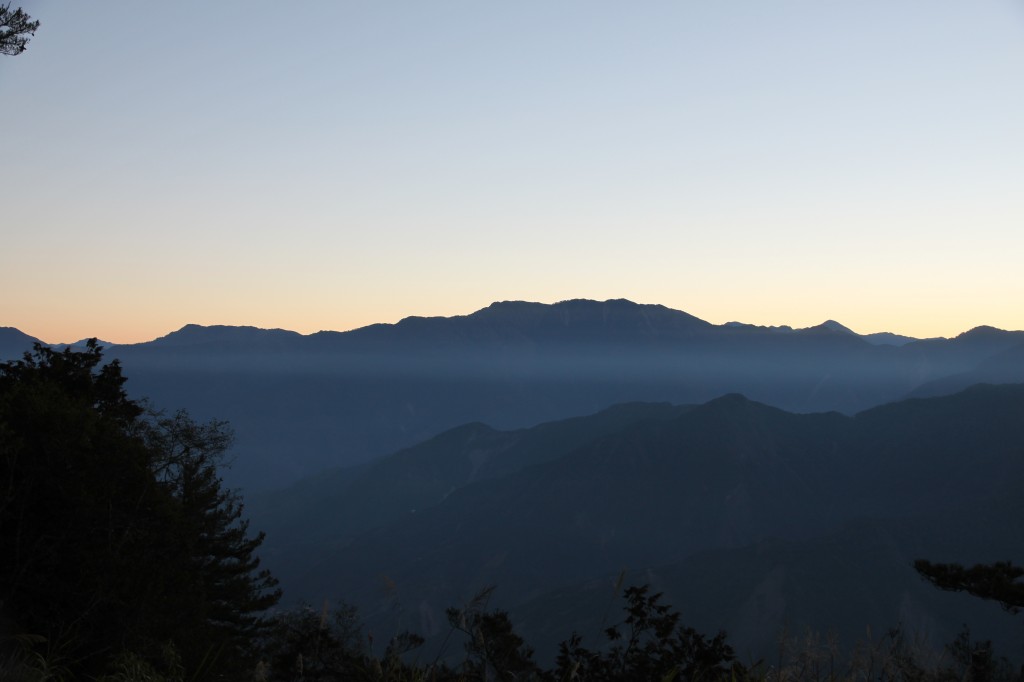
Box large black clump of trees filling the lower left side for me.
[0,340,280,676]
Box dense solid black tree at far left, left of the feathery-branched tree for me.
[0,337,156,657]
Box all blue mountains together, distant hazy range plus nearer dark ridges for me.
[8,300,1024,658]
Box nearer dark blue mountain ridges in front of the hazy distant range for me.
[250,385,1024,657]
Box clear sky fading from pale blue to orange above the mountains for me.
[0,0,1024,343]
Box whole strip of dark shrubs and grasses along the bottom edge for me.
[128,587,1020,682]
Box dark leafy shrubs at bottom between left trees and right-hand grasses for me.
[249,586,745,682]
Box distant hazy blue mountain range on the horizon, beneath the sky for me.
[0,300,1024,491]
